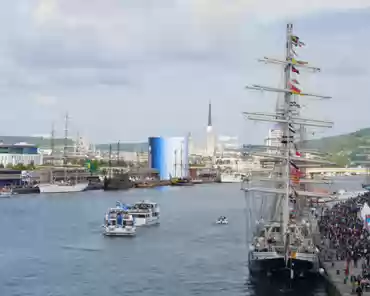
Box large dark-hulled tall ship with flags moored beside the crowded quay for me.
[243,24,333,277]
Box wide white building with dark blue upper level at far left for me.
[0,143,43,167]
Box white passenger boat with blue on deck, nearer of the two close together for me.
[104,208,136,236]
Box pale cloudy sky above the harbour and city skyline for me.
[0,0,370,143]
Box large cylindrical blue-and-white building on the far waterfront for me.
[148,137,189,180]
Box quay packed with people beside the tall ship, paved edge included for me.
[317,193,370,296]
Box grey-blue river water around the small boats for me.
[0,179,364,296]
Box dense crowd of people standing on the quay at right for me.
[319,193,370,295]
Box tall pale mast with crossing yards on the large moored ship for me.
[244,24,333,262]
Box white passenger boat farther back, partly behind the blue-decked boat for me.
[128,200,160,226]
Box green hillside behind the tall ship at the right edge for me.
[306,128,370,166]
